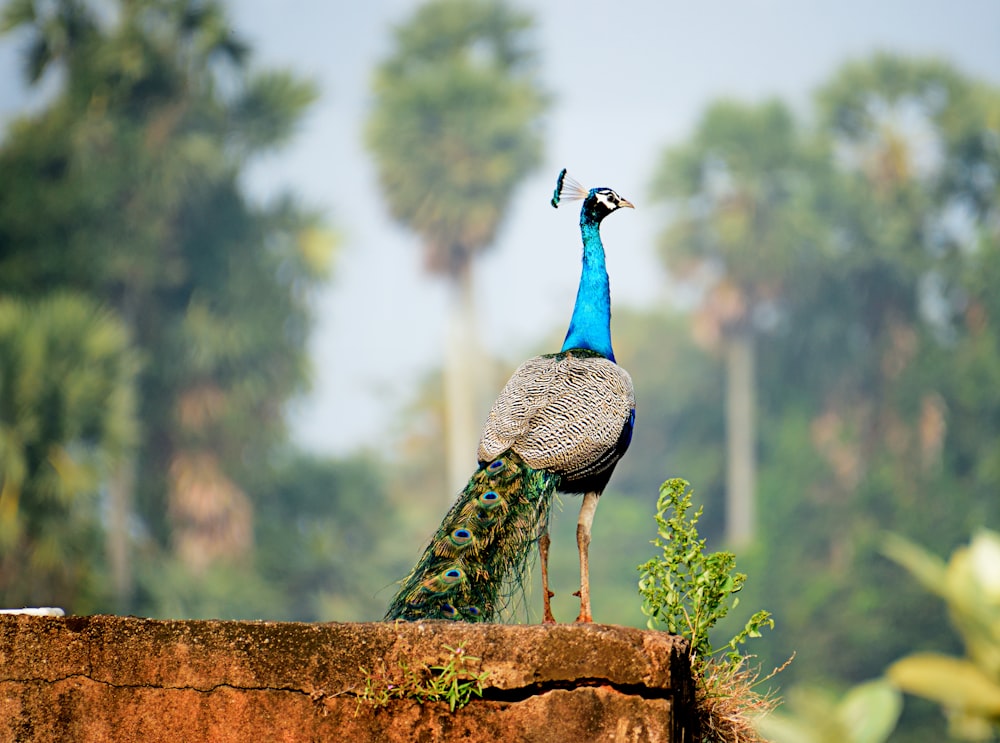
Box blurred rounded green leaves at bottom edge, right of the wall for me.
[756,679,903,743]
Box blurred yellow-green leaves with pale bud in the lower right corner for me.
[884,529,1000,740]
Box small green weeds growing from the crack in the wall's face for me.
[358,642,490,712]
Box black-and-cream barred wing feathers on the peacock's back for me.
[479,351,635,474]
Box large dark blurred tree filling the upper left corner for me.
[0,0,329,608]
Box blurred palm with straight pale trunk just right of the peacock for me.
[653,101,827,546]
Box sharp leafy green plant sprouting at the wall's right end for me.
[638,478,774,665]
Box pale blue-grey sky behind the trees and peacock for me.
[0,0,1000,456]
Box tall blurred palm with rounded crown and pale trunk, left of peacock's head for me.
[366,0,548,500]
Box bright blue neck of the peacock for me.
[562,218,615,361]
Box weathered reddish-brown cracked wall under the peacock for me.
[0,616,692,743]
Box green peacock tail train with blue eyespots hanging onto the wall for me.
[385,451,560,622]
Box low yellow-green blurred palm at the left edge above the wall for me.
[0,293,138,611]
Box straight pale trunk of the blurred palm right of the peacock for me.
[726,330,756,547]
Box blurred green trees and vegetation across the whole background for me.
[0,0,1000,741]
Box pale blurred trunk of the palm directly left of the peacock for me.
[444,261,481,504]
